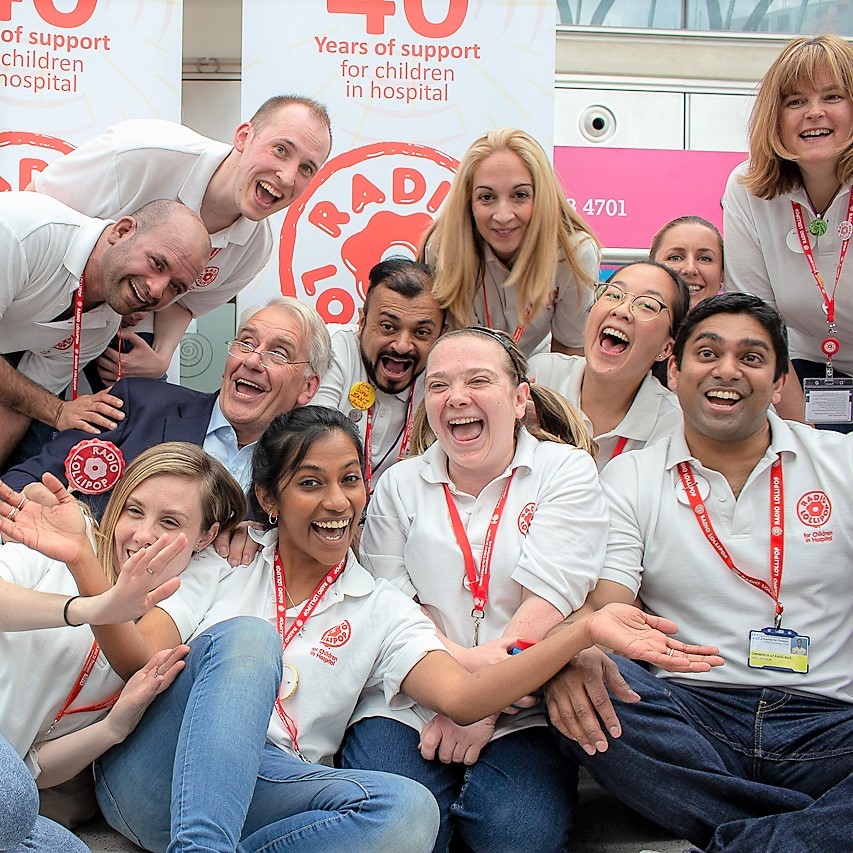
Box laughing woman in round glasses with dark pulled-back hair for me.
[530,261,690,470]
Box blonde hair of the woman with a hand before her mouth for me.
[95,441,246,583]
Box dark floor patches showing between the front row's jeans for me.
[71,775,690,853]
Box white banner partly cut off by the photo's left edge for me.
[0,0,183,191]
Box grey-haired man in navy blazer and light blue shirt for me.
[3,297,331,518]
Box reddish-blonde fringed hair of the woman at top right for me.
[740,35,853,200]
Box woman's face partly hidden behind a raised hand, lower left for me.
[113,474,219,580]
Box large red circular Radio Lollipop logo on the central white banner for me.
[279,142,459,323]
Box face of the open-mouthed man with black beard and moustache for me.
[358,284,442,394]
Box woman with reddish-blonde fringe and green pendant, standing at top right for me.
[723,35,853,432]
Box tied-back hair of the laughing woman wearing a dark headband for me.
[409,326,598,459]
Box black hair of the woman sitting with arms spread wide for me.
[249,406,364,530]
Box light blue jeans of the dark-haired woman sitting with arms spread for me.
[95,617,438,853]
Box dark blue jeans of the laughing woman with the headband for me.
[339,717,577,853]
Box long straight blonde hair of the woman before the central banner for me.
[418,128,600,328]
